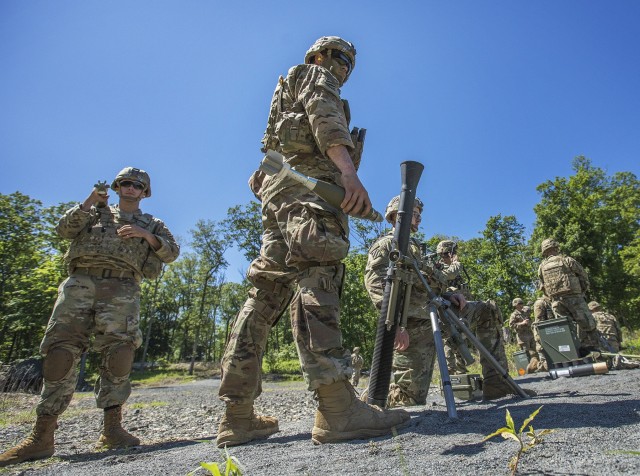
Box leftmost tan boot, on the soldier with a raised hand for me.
[0,415,58,467]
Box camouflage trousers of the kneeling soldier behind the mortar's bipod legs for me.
[452,300,509,388]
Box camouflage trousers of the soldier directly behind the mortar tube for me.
[387,319,436,407]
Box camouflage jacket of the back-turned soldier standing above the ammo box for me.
[538,255,589,298]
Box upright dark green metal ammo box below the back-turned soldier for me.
[536,317,580,368]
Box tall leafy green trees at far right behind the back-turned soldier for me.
[531,156,640,325]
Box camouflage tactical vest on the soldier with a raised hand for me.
[65,206,158,277]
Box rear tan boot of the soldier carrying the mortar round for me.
[216,402,279,448]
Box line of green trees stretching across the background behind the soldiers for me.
[0,157,640,370]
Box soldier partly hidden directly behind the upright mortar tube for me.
[365,196,446,407]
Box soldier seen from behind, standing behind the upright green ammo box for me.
[538,238,599,355]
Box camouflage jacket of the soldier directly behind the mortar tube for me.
[364,231,447,319]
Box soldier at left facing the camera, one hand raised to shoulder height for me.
[0,167,180,466]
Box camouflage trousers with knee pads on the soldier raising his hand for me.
[36,274,142,415]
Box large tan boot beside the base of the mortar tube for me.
[311,380,411,444]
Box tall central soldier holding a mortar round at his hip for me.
[217,37,410,447]
